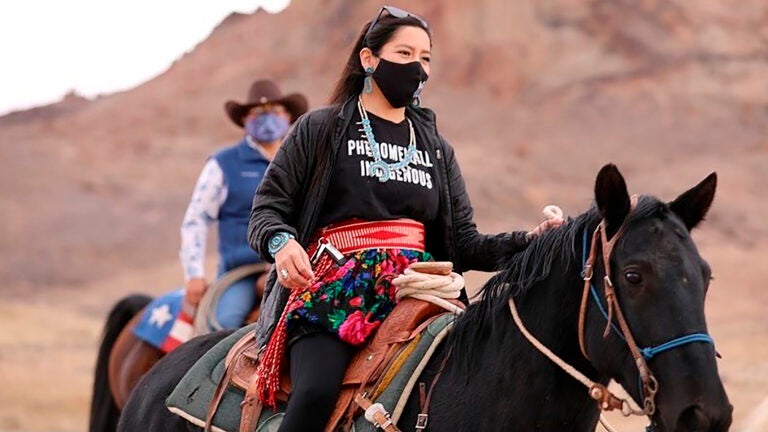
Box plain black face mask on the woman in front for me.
[373,59,429,108]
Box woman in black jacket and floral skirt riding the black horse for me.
[244,6,562,432]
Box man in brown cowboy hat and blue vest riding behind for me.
[179,80,308,328]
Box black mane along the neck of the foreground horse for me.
[447,195,670,376]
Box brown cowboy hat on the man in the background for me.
[224,80,309,127]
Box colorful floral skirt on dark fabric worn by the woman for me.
[288,249,432,345]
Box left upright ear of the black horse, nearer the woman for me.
[595,164,630,238]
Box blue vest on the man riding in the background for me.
[212,139,269,272]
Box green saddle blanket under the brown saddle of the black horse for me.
[165,313,456,432]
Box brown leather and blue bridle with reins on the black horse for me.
[509,196,714,426]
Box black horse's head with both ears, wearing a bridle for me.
[581,165,733,432]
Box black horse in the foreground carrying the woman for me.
[118,165,732,432]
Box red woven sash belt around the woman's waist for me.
[308,219,424,264]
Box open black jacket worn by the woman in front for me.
[248,100,528,345]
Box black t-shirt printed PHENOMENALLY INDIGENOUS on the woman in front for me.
[319,111,440,227]
